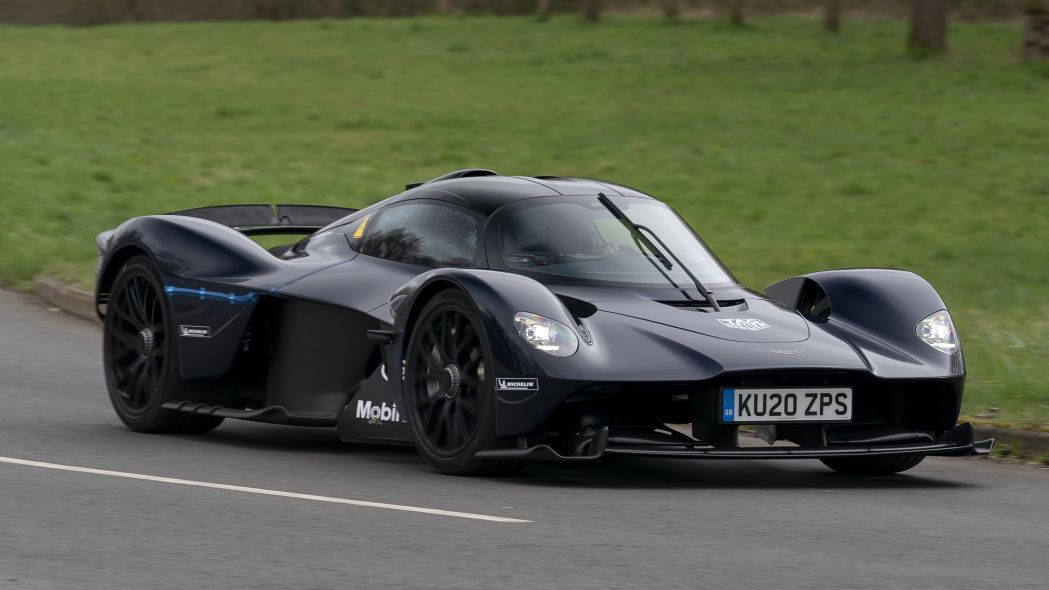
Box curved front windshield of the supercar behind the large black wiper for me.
[490,196,734,289]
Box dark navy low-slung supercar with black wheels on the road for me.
[95,169,991,473]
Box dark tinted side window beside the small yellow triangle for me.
[355,202,483,269]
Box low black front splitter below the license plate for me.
[477,423,994,462]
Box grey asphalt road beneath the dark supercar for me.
[0,291,1049,590]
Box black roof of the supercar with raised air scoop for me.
[386,169,652,216]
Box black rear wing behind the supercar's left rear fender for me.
[168,205,357,235]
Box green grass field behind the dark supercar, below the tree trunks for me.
[0,17,1049,425]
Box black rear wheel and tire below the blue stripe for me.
[103,256,222,434]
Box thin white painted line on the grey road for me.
[0,457,532,523]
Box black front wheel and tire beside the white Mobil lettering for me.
[404,290,525,476]
